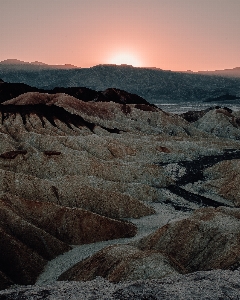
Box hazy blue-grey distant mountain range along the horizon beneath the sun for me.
[0,60,240,104]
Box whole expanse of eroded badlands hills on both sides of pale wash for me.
[0,83,240,288]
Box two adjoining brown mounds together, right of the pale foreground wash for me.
[58,207,240,282]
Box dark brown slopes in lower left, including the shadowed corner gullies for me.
[0,194,136,287]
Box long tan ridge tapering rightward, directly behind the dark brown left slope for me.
[0,170,154,218]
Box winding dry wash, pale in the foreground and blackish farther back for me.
[36,149,240,285]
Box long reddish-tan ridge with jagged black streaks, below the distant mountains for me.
[1,93,207,136]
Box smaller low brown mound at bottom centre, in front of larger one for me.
[58,245,183,282]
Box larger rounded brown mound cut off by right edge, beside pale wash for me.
[134,207,240,272]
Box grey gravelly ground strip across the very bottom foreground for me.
[0,270,240,300]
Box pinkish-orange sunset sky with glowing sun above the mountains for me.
[0,0,240,71]
